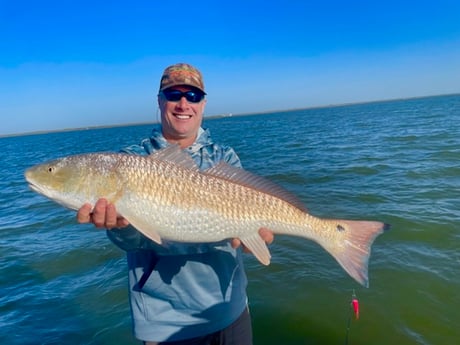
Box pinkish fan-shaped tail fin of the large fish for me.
[321,220,390,287]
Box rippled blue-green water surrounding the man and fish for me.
[0,95,460,345]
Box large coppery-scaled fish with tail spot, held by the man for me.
[24,145,389,287]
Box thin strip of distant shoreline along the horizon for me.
[0,93,460,139]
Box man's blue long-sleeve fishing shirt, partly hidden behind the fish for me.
[107,128,247,341]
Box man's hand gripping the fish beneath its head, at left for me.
[77,199,129,229]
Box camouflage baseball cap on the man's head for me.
[160,63,204,92]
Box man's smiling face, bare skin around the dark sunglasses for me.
[158,85,206,148]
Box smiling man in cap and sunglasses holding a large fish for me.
[77,63,273,345]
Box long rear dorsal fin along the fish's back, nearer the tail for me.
[204,162,307,212]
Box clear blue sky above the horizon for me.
[0,0,460,135]
